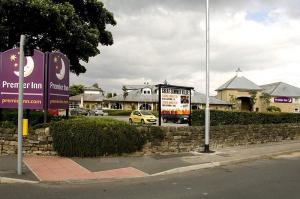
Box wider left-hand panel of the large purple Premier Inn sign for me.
[0,48,44,109]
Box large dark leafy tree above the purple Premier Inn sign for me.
[0,0,116,75]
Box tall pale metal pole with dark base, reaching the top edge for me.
[204,0,210,153]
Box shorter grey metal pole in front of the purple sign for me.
[17,35,25,175]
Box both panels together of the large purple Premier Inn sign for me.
[0,48,69,109]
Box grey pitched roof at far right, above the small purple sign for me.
[260,82,300,97]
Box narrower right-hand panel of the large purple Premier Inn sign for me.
[48,52,70,109]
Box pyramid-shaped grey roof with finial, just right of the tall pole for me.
[216,76,262,91]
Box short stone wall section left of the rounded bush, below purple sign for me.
[0,128,56,155]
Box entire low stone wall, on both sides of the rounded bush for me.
[0,123,300,155]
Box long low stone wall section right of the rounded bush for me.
[143,124,300,153]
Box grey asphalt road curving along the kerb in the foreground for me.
[0,157,300,199]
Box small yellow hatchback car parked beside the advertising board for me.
[129,110,157,124]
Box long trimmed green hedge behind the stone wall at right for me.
[192,110,300,126]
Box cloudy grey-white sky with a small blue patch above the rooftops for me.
[71,0,300,95]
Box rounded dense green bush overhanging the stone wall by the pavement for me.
[50,118,146,157]
